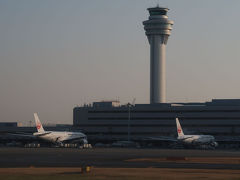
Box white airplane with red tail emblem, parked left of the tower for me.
[33,113,88,145]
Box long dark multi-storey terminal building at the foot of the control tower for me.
[73,99,240,143]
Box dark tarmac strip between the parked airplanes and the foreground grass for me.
[0,148,240,169]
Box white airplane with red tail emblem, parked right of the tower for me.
[176,118,218,148]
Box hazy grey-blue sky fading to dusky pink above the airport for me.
[0,0,240,124]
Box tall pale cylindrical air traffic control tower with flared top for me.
[143,6,173,104]
